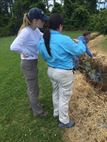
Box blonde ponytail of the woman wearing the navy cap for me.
[18,13,31,34]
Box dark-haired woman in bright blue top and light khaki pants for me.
[38,14,86,128]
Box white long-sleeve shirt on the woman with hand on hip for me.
[10,26,43,60]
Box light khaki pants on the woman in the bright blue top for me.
[48,67,74,124]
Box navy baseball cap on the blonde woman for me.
[28,8,48,21]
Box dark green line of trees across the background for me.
[0,0,107,36]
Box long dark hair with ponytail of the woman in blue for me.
[43,13,63,56]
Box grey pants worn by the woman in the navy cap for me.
[21,59,43,115]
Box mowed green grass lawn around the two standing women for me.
[0,32,80,142]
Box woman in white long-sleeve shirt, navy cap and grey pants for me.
[10,8,48,116]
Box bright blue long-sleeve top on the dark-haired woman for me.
[38,30,86,69]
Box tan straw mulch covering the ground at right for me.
[64,35,107,142]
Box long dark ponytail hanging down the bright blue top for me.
[43,29,51,56]
